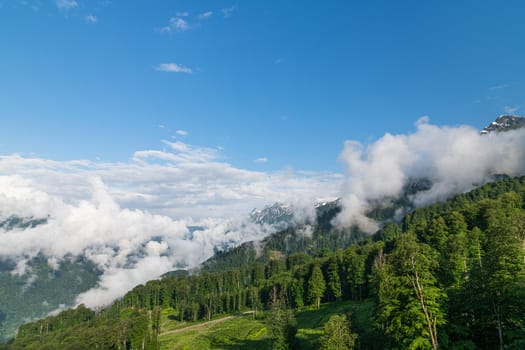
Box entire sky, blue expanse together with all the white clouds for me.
[0,0,525,306]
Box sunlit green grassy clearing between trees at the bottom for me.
[159,301,373,350]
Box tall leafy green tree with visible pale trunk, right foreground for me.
[377,234,445,350]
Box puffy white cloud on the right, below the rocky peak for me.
[335,117,525,232]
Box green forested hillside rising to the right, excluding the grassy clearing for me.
[6,177,525,349]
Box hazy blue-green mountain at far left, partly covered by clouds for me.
[0,216,100,342]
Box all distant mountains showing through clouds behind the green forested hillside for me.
[0,115,525,340]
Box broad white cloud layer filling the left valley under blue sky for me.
[0,141,342,306]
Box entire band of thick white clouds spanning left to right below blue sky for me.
[0,118,525,307]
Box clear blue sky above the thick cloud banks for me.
[0,0,525,172]
